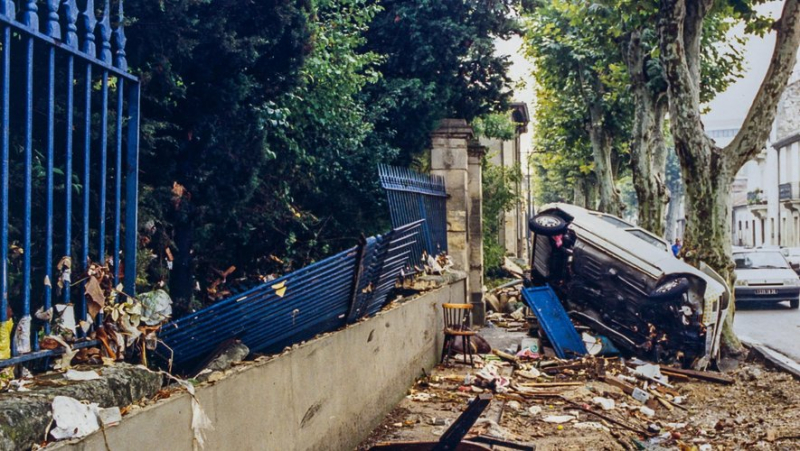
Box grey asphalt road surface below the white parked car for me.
[733,302,800,362]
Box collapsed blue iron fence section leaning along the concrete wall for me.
[156,221,422,368]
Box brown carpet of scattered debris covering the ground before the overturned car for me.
[358,308,800,451]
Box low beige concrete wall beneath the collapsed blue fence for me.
[55,279,466,451]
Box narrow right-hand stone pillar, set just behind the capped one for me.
[467,140,486,326]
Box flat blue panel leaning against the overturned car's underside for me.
[522,286,586,359]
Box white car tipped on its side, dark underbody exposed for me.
[526,204,730,369]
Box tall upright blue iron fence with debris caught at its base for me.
[0,0,140,366]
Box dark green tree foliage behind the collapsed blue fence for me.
[126,0,518,312]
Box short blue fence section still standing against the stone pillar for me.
[378,165,447,270]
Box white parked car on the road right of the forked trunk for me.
[733,249,800,308]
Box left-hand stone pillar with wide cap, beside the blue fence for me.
[431,119,473,278]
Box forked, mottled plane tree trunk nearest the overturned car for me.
[659,0,800,355]
